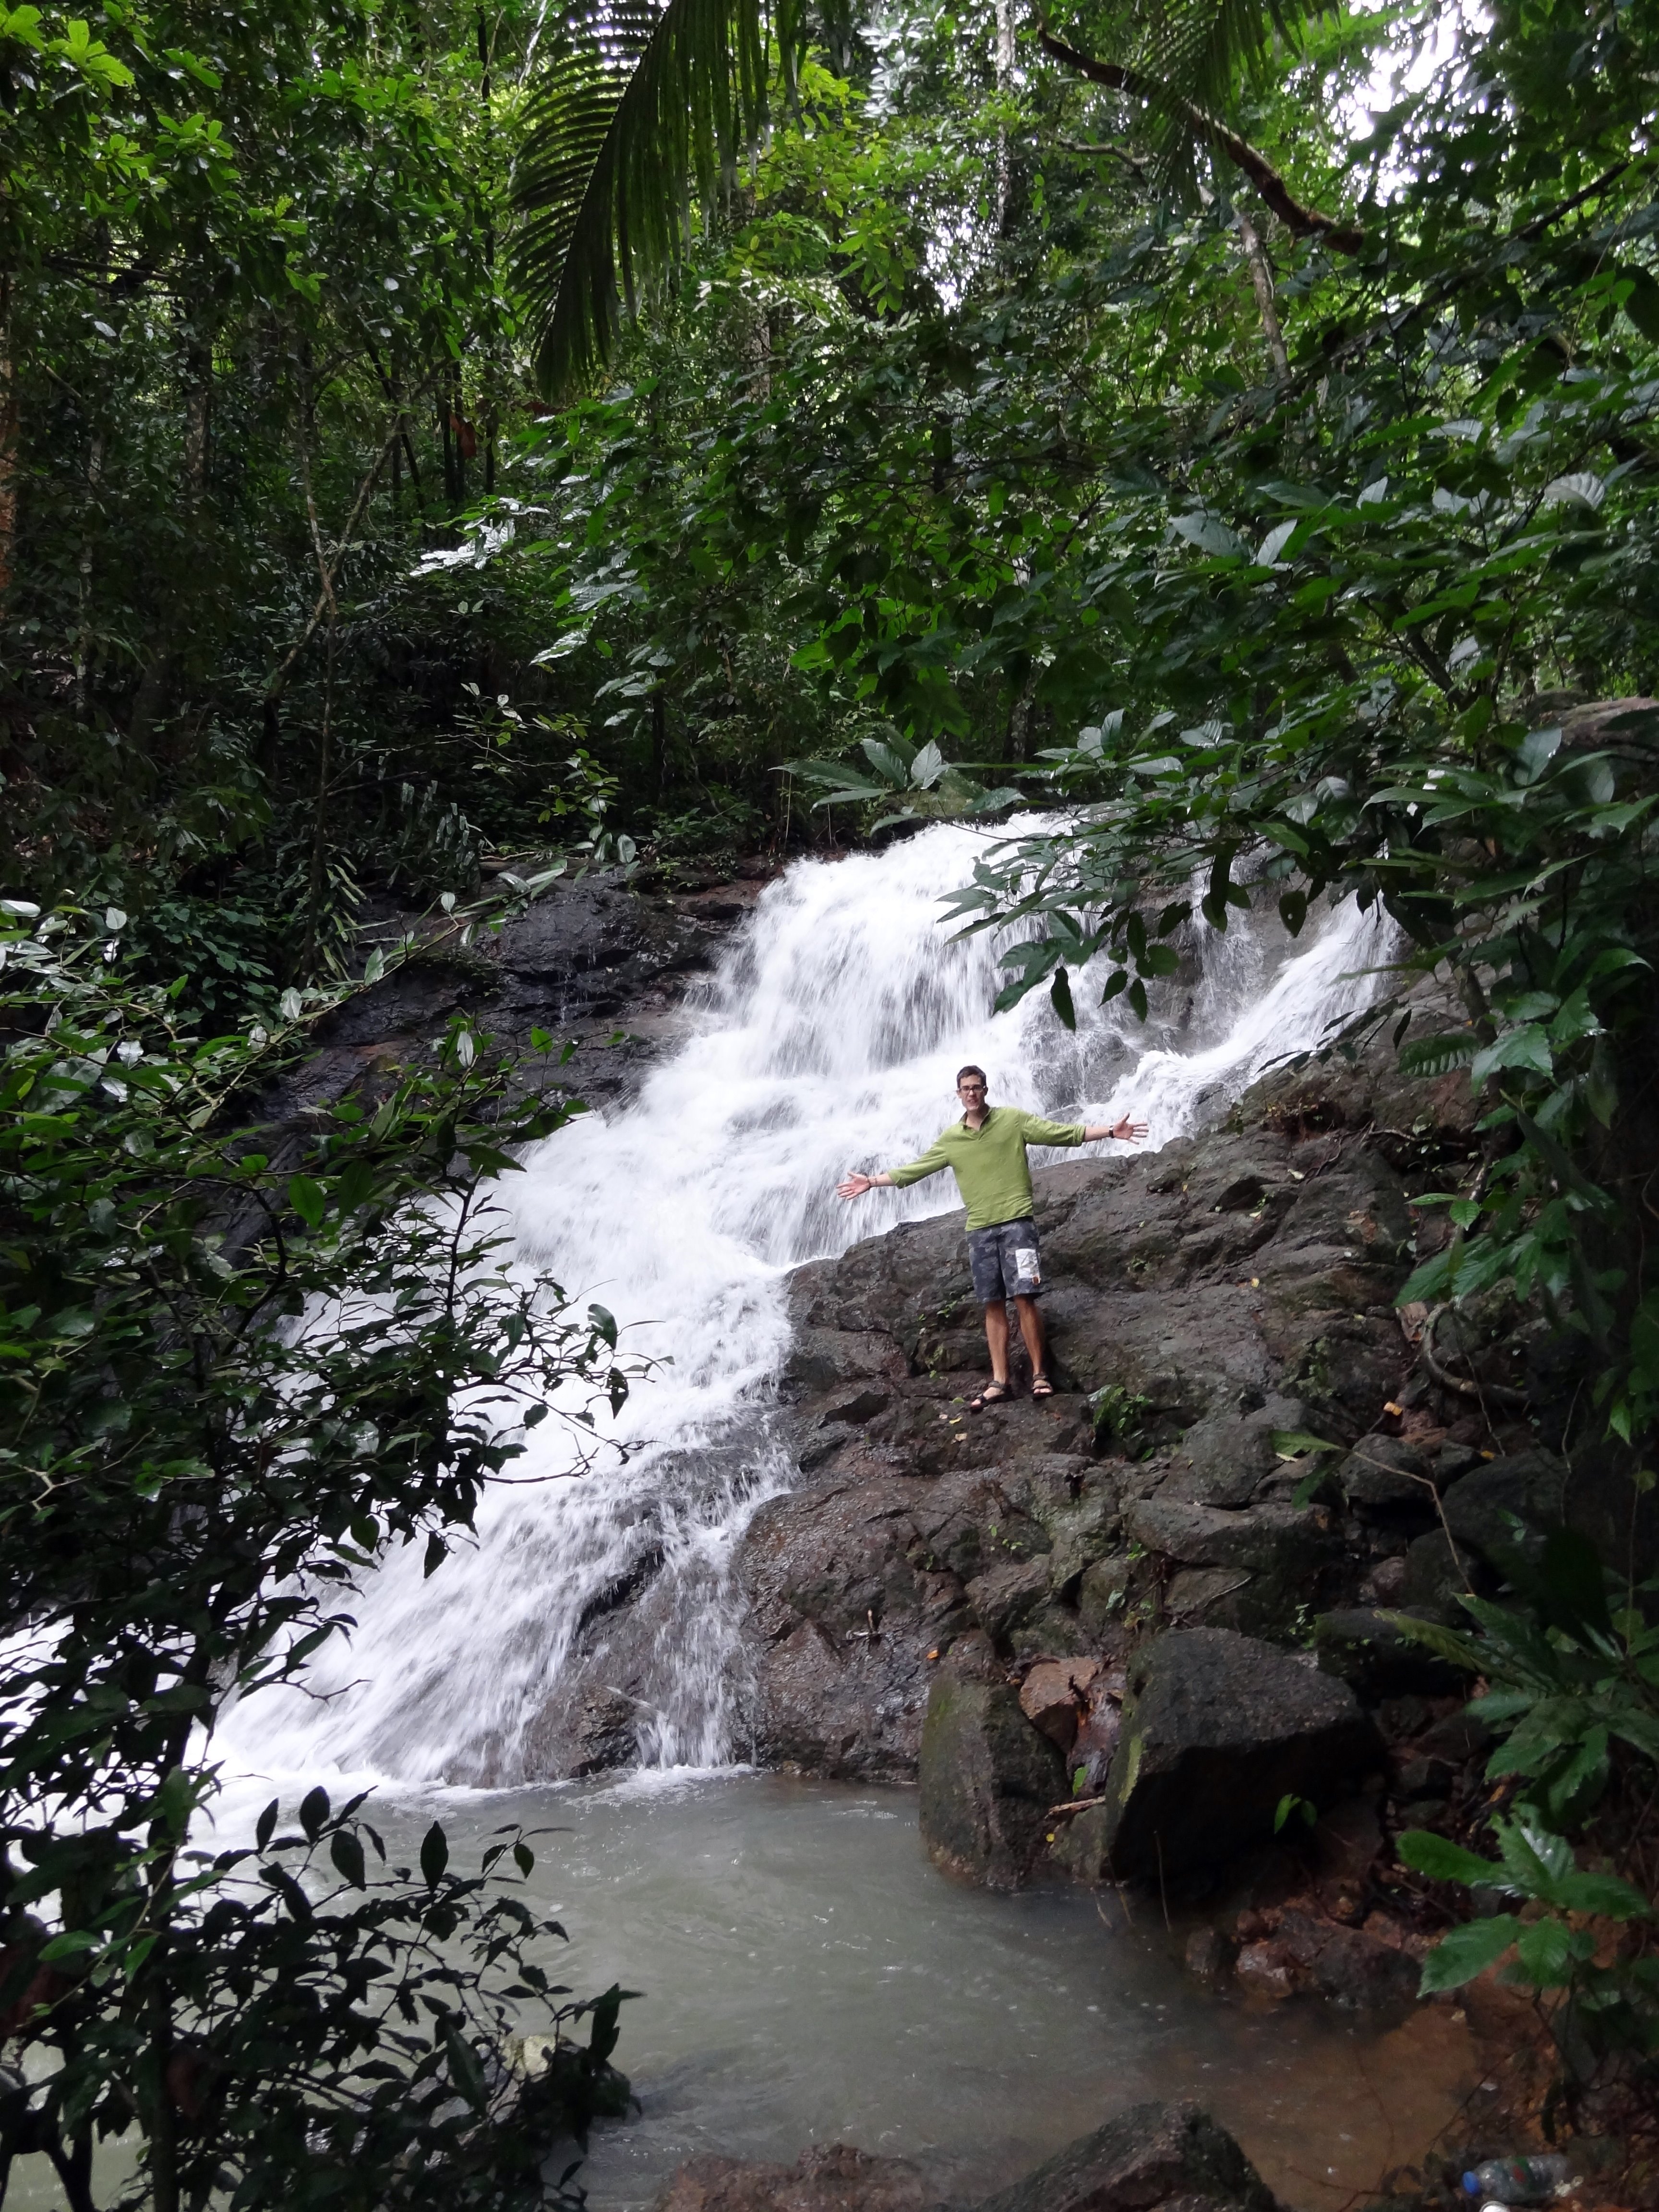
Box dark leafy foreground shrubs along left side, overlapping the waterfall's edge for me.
[0,902,628,2212]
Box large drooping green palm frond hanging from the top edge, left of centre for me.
[513,0,796,392]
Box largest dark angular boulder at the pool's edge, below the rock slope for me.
[1055,1628,1382,1880]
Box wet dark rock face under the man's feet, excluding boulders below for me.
[739,1093,1429,1779]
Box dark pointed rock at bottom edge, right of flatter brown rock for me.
[982,2104,1278,2212]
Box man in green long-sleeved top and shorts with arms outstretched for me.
[836,1069,1146,1414]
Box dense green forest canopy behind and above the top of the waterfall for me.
[0,7,1659,986]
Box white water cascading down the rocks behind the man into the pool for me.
[221,827,1385,1783]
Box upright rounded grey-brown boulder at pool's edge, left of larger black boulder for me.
[920,1637,1066,1889]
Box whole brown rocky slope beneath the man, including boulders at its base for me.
[739,1017,1628,2002]
